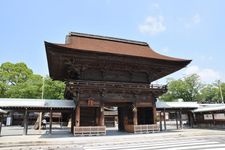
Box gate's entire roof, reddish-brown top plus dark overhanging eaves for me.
[45,32,191,83]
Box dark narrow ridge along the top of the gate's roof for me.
[69,32,149,46]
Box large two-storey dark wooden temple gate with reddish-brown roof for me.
[45,32,190,135]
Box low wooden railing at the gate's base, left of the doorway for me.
[74,126,106,136]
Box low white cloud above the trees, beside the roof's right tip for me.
[185,65,221,83]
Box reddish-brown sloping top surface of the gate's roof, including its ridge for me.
[46,32,190,62]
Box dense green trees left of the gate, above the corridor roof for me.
[0,62,65,99]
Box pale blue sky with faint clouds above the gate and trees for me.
[0,0,225,83]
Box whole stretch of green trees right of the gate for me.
[160,74,225,103]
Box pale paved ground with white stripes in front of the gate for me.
[0,129,225,150]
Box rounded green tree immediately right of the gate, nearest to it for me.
[160,74,202,101]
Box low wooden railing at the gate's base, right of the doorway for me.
[125,124,160,133]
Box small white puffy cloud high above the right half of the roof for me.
[139,16,166,35]
